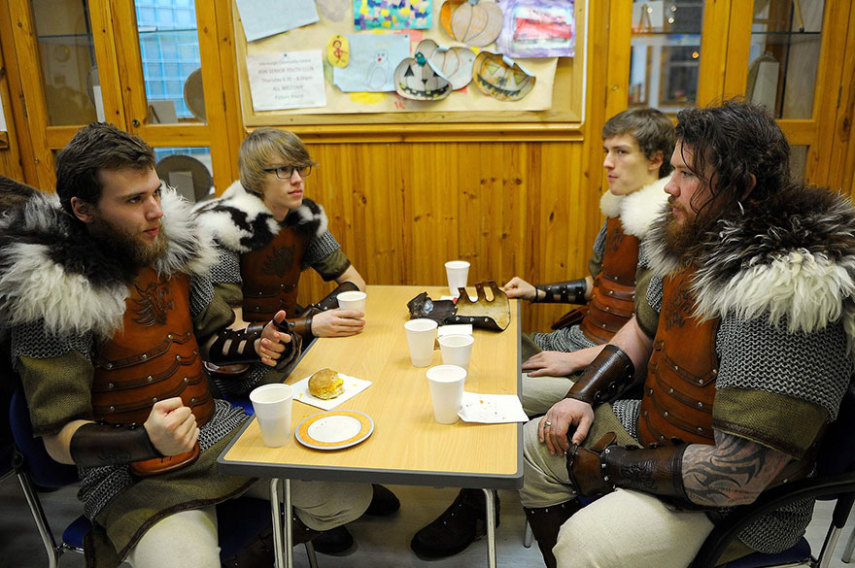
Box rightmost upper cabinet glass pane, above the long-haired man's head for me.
[745,0,825,118]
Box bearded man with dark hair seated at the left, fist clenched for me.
[0,123,371,568]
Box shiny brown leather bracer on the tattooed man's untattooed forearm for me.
[564,344,635,406]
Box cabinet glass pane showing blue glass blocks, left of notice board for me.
[135,0,205,124]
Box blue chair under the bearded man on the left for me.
[9,390,317,568]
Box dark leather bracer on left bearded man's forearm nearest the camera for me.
[70,422,163,467]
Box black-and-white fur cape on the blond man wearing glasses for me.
[196,181,328,254]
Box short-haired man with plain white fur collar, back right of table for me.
[410,108,674,558]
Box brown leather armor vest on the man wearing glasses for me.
[240,227,309,322]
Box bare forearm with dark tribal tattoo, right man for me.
[683,432,790,507]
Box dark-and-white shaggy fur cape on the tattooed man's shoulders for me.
[647,187,855,338]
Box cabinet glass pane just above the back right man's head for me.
[629,0,704,113]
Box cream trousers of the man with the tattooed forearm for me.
[520,404,713,568]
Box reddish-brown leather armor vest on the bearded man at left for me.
[92,268,214,426]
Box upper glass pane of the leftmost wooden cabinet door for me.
[30,0,99,126]
